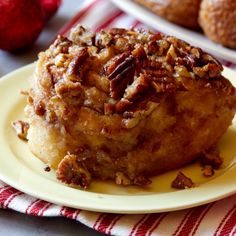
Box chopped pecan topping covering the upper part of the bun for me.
[30,26,235,120]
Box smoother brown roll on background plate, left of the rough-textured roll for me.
[135,0,201,29]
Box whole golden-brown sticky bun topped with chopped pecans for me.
[25,26,236,188]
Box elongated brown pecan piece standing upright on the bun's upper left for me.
[67,48,89,81]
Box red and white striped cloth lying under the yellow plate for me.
[0,0,236,236]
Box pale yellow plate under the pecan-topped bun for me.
[0,64,236,213]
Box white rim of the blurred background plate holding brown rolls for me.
[110,0,236,63]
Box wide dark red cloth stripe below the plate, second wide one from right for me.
[179,205,208,236]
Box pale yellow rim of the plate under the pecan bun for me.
[0,64,236,214]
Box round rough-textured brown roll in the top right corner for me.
[199,0,236,49]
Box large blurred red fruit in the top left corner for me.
[0,0,45,52]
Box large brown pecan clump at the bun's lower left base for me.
[57,154,91,189]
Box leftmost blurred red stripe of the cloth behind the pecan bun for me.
[58,0,100,35]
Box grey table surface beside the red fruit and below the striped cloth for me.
[0,0,101,236]
